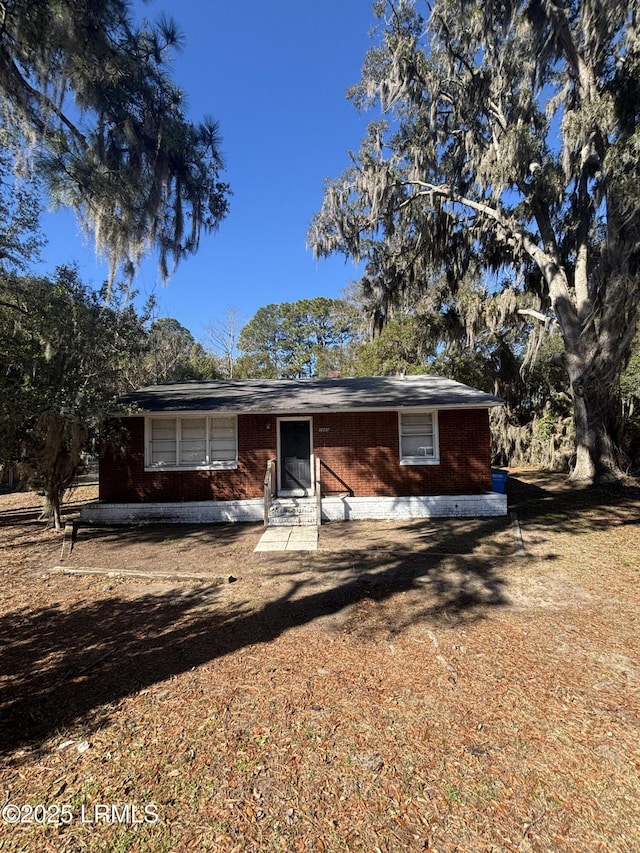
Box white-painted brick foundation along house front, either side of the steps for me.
[80,492,507,525]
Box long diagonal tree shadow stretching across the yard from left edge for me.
[0,519,513,753]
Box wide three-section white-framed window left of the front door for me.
[145,415,238,470]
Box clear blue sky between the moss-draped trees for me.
[37,0,375,338]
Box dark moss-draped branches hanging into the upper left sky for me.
[0,0,229,280]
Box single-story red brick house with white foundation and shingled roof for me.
[84,375,506,523]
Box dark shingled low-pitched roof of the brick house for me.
[120,375,503,414]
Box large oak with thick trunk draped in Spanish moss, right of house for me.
[309,0,640,481]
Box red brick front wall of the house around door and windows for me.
[100,409,491,503]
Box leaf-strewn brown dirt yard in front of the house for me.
[0,471,640,853]
